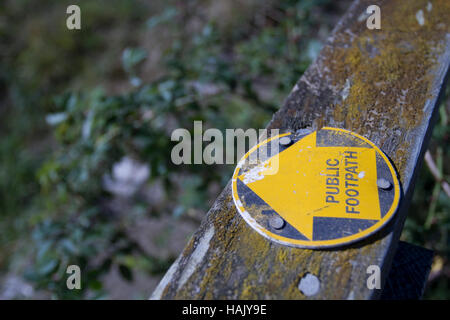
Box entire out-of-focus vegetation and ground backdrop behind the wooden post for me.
[0,0,450,299]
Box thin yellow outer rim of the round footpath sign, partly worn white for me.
[231,127,400,249]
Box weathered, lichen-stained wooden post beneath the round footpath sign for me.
[151,0,450,299]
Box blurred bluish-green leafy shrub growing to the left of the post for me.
[16,1,330,298]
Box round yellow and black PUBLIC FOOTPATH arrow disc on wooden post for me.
[232,127,400,249]
